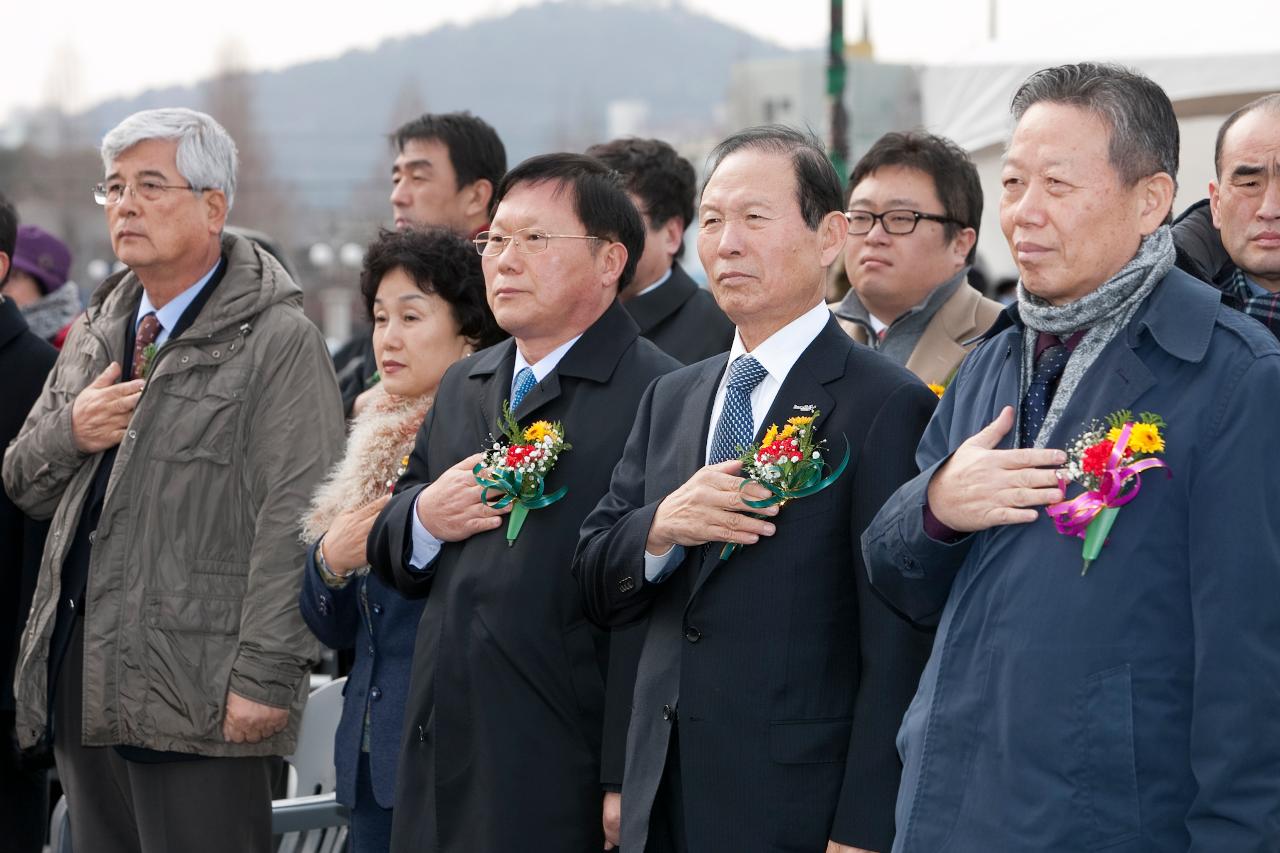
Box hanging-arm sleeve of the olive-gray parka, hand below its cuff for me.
[229,318,346,708]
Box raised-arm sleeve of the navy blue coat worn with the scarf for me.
[861,374,973,626]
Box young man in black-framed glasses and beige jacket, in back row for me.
[833,133,1001,387]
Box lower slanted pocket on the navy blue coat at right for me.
[1080,663,1142,850]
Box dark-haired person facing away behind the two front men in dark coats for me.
[586,138,733,364]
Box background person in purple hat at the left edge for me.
[4,225,83,348]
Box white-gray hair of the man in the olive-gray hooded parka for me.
[102,106,237,210]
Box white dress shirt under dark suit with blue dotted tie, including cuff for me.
[644,302,831,583]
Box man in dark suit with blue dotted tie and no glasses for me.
[575,127,936,853]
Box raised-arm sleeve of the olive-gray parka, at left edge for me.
[4,319,90,521]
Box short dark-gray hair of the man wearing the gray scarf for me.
[1010,63,1179,188]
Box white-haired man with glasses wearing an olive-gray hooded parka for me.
[4,109,343,853]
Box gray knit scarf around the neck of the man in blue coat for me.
[1014,225,1175,447]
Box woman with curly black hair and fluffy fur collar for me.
[301,228,506,853]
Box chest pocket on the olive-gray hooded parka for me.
[151,370,248,465]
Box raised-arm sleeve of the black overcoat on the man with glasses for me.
[365,406,438,598]
